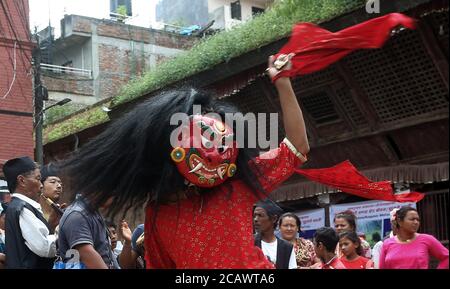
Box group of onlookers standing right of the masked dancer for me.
[254,201,449,269]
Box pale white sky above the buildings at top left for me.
[29,0,158,37]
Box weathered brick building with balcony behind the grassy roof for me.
[40,15,195,105]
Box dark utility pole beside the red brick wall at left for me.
[33,33,44,166]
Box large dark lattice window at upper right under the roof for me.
[345,30,448,124]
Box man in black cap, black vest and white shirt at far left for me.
[3,157,59,269]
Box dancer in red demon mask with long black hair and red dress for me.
[60,55,309,269]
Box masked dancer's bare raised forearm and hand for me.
[267,55,309,155]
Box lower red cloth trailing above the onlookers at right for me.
[295,161,425,203]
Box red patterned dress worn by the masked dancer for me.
[145,139,306,269]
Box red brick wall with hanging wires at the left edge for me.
[0,0,34,170]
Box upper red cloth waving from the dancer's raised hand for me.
[273,13,415,81]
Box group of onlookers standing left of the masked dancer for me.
[0,157,145,269]
